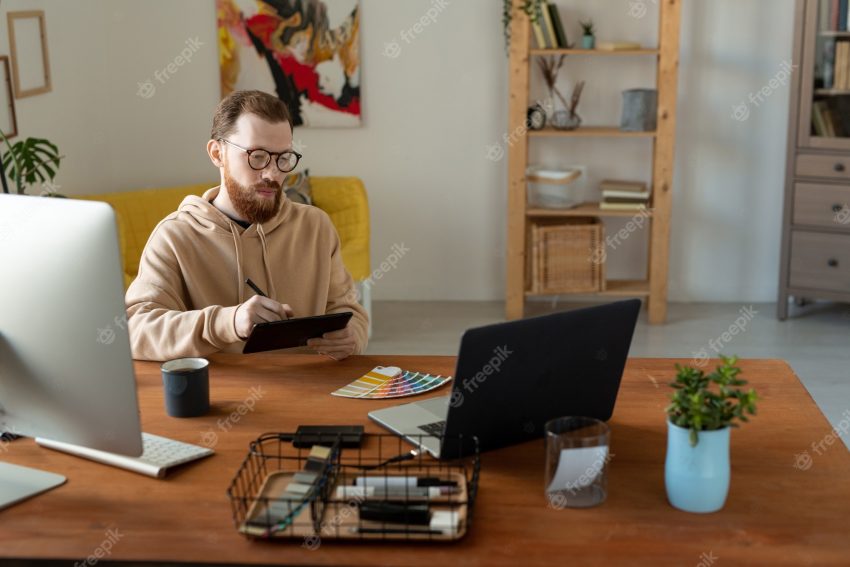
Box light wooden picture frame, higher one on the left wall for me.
[6,10,51,98]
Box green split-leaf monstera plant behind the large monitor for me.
[0,132,64,197]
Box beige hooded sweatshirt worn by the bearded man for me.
[125,187,368,360]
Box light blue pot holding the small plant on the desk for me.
[664,421,730,514]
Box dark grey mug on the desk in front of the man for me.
[160,358,210,417]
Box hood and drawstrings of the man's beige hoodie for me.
[177,185,292,303]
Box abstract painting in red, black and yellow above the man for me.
[216,0,361,127]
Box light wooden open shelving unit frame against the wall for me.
[505,0,681,324]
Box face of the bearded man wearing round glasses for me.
[221,114,292,223]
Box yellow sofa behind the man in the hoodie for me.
[75,177,372,327]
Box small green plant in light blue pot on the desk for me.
[664,356,757,513]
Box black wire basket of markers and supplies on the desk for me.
[227,433,481,548]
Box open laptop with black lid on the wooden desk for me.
[369,299,641,458]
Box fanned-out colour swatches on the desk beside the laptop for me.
[331,366,452,399]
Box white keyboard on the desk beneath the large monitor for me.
[35,433,214,478]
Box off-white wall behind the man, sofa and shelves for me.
[0,0,793,301]
